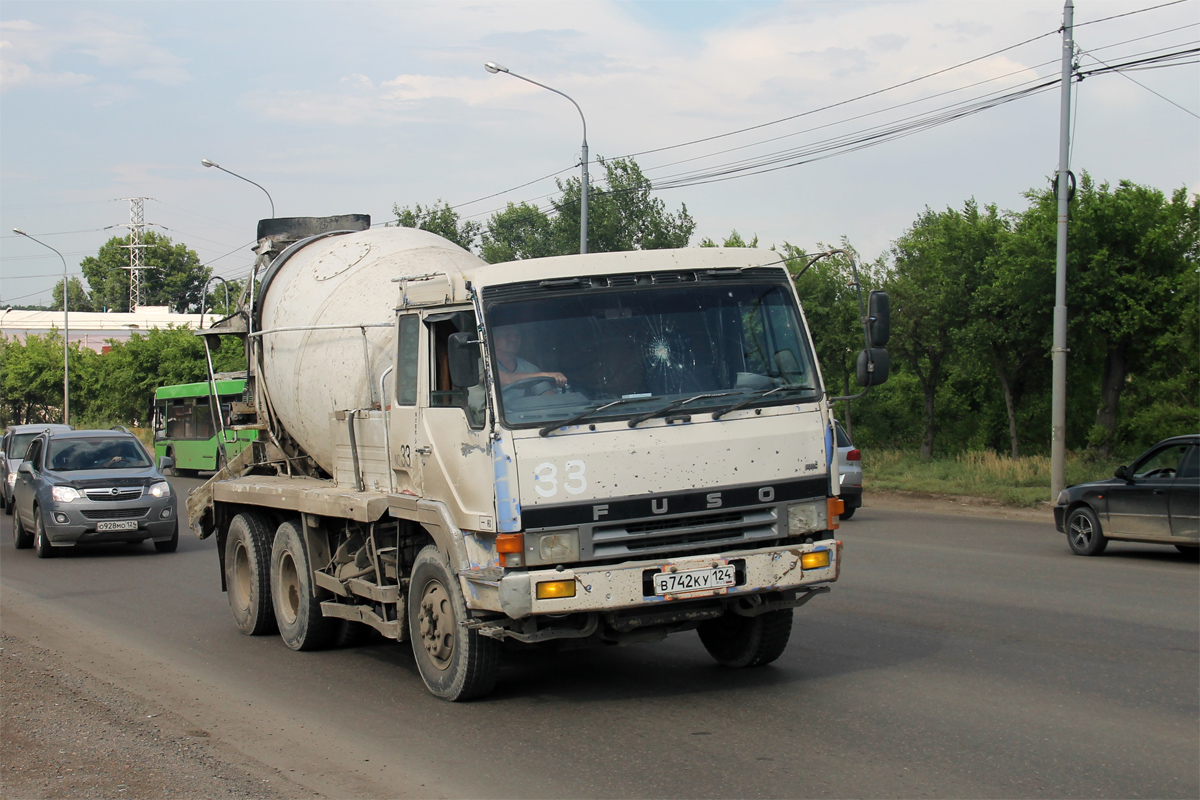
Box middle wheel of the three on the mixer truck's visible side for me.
[271,522,337,650]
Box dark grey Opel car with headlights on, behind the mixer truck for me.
[12,429,179,558]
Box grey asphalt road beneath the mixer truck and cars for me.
[0,479,1200,798]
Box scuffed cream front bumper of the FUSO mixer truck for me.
[482,540,841,619]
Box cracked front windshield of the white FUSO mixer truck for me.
[487,282,821,429]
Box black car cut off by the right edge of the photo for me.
[1054,434,1200,555]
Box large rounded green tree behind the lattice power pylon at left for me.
[79,230,211,313]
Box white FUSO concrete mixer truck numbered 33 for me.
[187,215,887,700]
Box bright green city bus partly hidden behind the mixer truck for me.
[154,379,258,475]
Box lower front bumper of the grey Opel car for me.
[40,495,179,547]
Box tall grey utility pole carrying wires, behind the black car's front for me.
[1050,0,1075,503]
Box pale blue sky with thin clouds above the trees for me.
[0,0,1200,308]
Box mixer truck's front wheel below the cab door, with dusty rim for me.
[408,545,500,702]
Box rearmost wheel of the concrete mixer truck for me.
[226,511,276,636]
